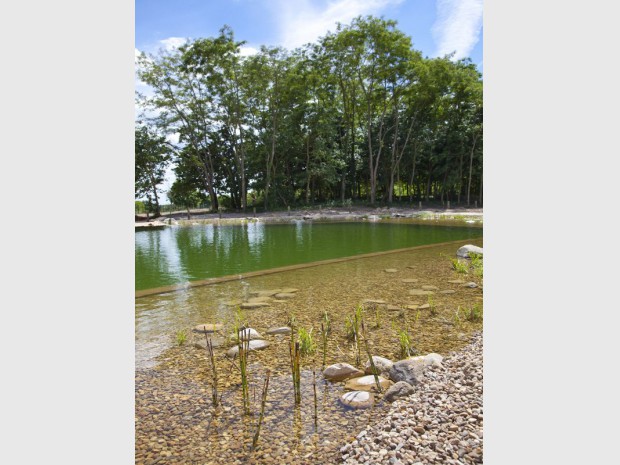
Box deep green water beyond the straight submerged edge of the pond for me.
[135,221,482,290]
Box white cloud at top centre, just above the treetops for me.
[276,0,403,49]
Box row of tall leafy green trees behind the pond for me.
[136,17,482,215]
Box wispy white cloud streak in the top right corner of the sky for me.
[433,0,483,60]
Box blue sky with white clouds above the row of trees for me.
[135,0,483,202]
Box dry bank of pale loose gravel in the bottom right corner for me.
[340,334,483,465]
